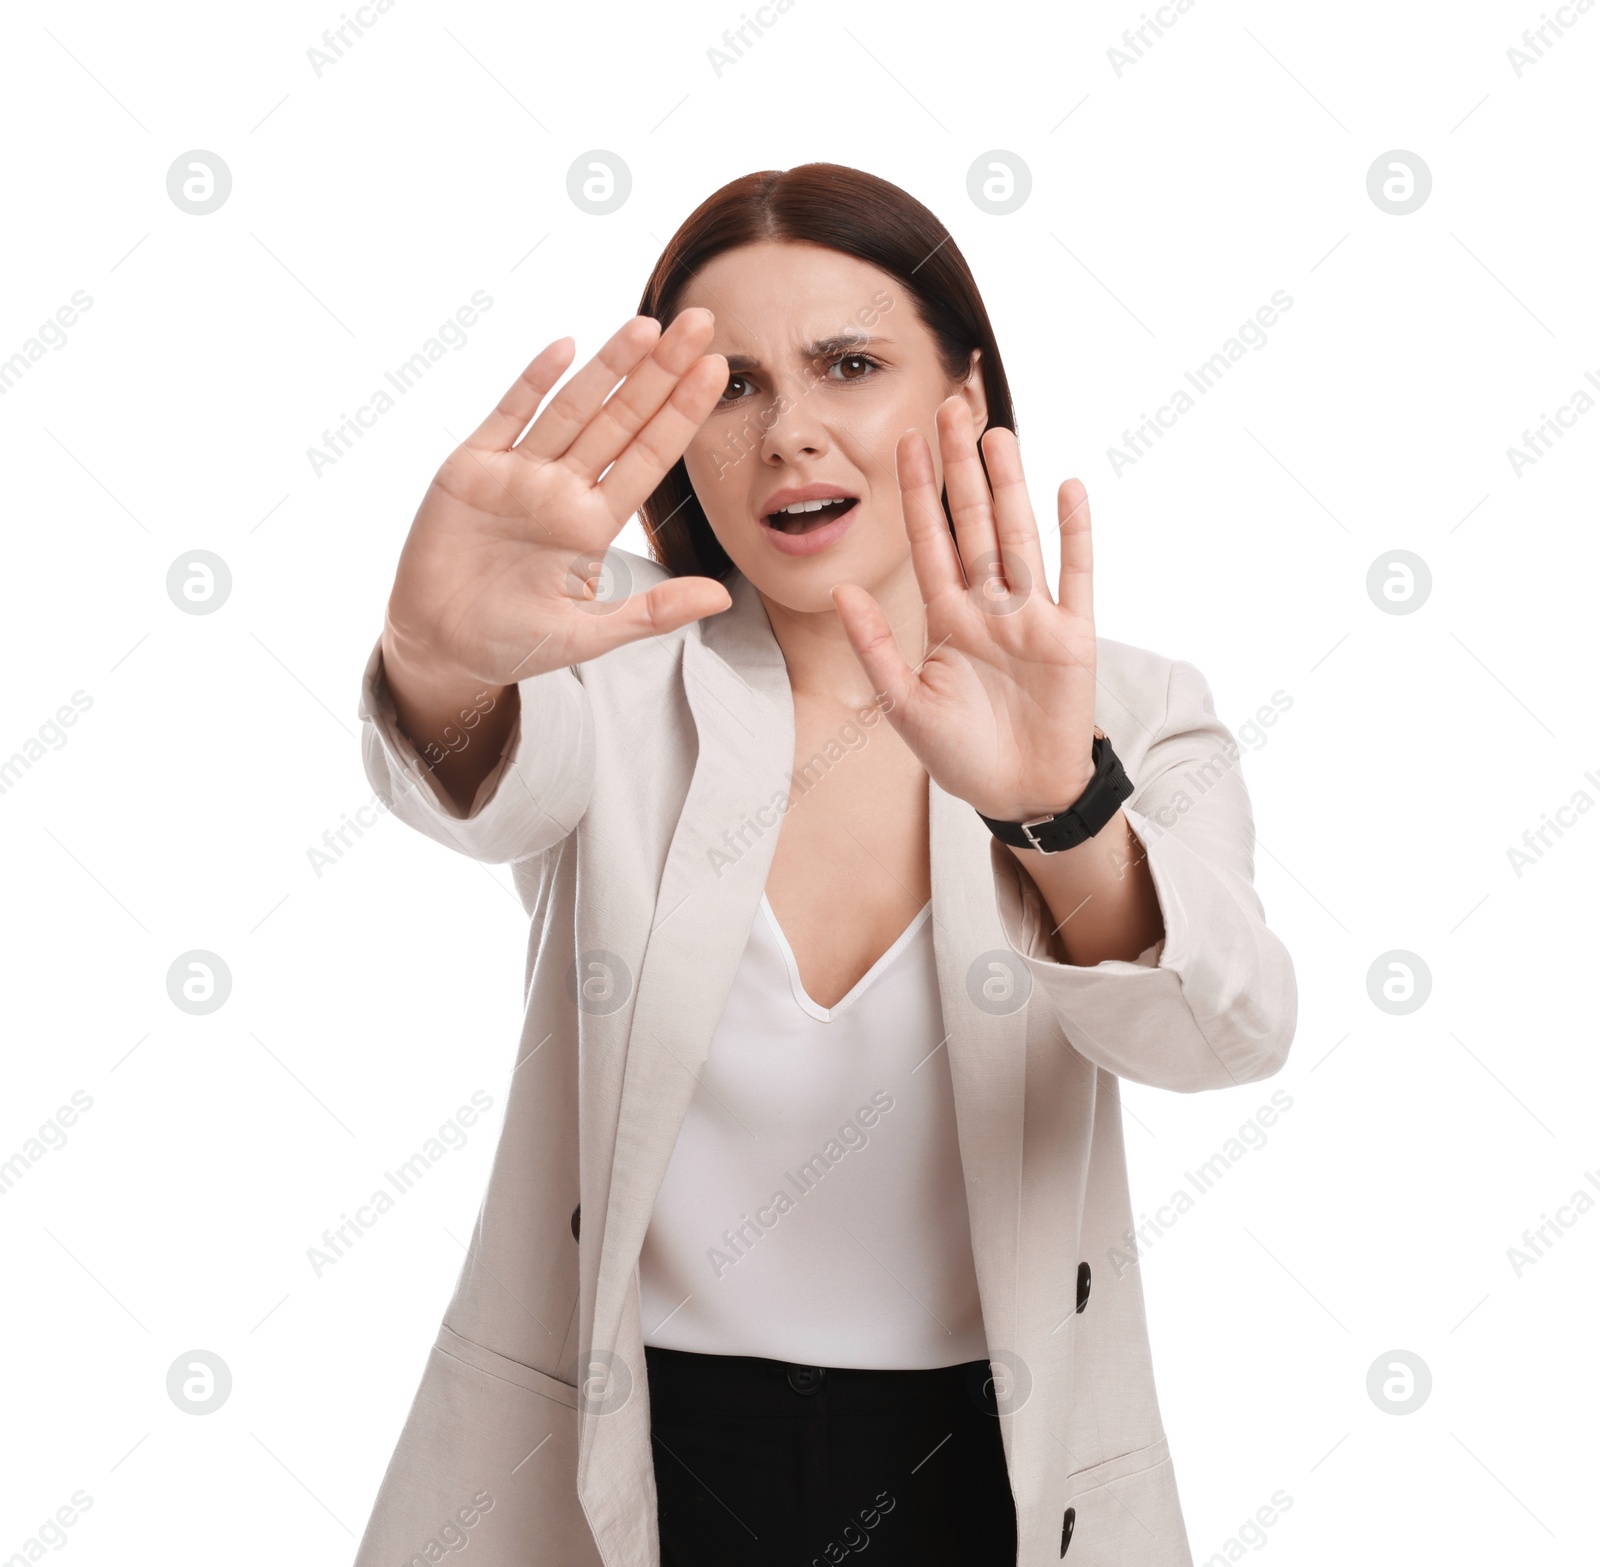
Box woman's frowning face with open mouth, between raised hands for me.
[678,240,986,611]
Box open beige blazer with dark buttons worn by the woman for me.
[355,549,1296,1567]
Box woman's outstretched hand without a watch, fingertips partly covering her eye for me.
[382,309,733,697]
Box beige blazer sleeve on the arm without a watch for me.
[357,639,595,864]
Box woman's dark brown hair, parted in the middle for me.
[638,163,1016,578]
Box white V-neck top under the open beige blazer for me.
[640,893,989,1370]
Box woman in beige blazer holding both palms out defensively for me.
[358,165,1296,1567]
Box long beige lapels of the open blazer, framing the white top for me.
[582,570,1027,1468]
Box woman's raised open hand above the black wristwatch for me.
[834,397,1094,821]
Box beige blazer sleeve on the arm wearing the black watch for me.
[990,659,1298,1093]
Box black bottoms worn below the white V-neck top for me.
[645,1345,1016,1567]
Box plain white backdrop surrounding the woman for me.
[0,0,1600,1564]
